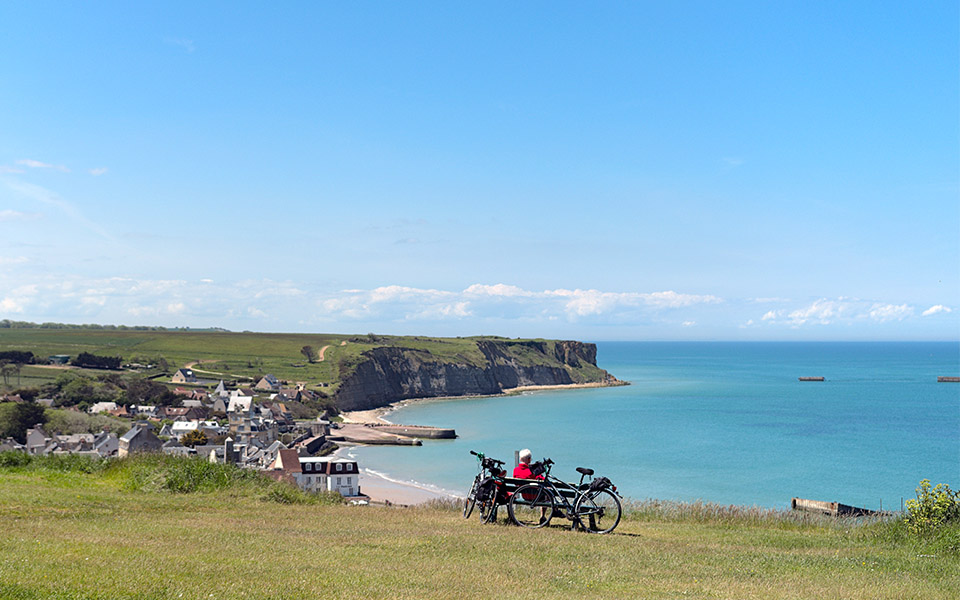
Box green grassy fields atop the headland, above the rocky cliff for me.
[0,329,616,395]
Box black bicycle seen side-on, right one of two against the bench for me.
[507,458,623,533]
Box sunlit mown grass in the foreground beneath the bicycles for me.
[0,459,960,599]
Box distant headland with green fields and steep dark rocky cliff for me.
[0,320,625,410]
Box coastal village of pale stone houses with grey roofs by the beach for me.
[0,360,454,504]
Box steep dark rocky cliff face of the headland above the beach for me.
[336,340,617,410]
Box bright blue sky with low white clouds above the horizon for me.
[0,2,960,340]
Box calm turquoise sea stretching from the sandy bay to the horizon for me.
[349,342,960,509]
